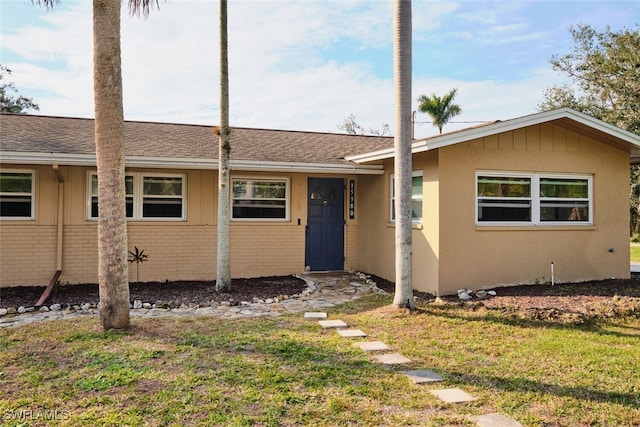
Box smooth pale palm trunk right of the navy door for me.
[393,0,415,310]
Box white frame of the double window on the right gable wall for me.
[474,171,594,227]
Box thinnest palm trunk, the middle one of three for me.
[216,0,231,292]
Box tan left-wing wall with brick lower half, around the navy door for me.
[0,165,359,286]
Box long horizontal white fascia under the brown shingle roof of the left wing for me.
[0,151,383,175]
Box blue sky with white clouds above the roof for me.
[0,0,640,138]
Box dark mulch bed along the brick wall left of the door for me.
[0,276,306,308]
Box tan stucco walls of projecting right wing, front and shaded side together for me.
[358,124,630,295]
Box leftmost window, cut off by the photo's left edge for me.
[0,170,35,219]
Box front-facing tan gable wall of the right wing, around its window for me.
[439,124,630,294]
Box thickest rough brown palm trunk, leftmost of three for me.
[93,0,129,330]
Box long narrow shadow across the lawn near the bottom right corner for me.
[438,370,640,409]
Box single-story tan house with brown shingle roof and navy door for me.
[0,108,640,295]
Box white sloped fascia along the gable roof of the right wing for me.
[346,108,640,163]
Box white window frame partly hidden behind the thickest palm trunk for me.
[87,170,187,222]
